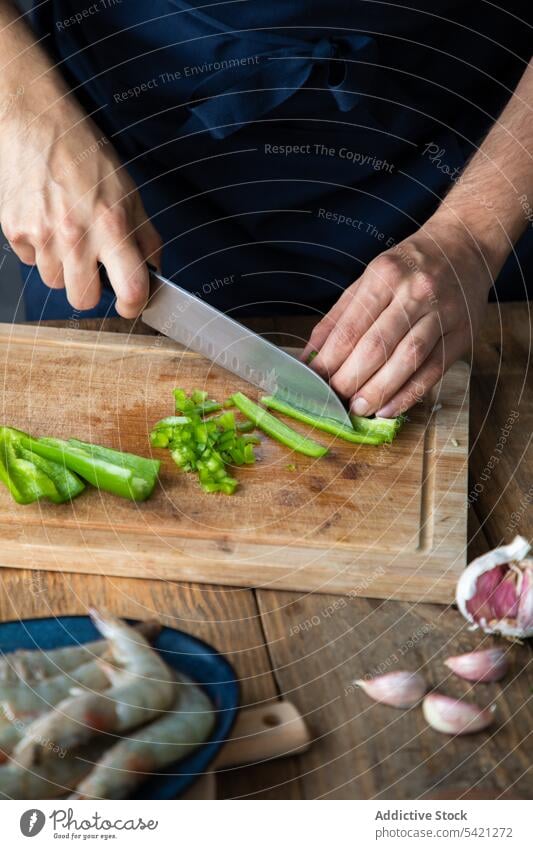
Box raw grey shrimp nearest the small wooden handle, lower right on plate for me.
[72,675,215,799]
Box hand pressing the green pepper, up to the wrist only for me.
[303,214,491,416]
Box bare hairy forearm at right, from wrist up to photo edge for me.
[430,63,533,278]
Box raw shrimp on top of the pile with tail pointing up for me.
[13,611,174,766]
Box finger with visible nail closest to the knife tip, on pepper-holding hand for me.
[350,313,443,416]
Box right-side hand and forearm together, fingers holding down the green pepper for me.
[303,58,533,416]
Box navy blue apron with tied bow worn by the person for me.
[25,0,533,319]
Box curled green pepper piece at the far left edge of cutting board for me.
[0,427,85,504]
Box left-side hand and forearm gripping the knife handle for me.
[0,4,161,318]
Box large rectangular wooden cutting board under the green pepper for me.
[0,324,468,604]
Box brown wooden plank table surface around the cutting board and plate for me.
[0,304,533,799]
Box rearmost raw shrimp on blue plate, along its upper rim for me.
[0,621,161,682]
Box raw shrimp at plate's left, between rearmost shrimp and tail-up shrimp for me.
[0,660,110,722]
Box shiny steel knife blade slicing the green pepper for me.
[142,266,352,429]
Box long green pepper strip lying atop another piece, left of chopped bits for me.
[22,437,160,501]
